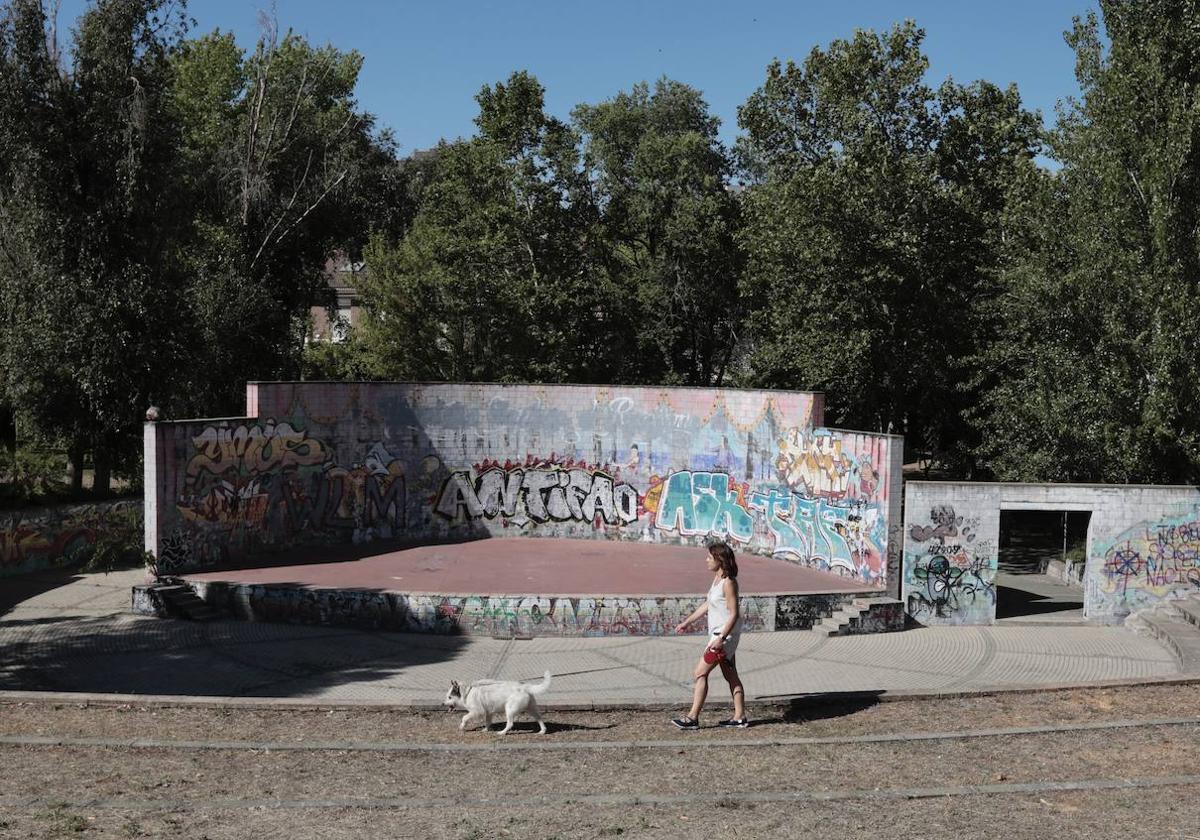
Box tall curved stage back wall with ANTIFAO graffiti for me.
[145,383,902,589]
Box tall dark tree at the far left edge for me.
[0,0,185,492]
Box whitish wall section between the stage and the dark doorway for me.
[904,481,1000,624]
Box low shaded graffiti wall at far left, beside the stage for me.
[0,499,142,576]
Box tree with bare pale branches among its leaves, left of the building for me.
[172,23,404,413]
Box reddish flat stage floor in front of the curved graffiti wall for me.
[185,538,880,598]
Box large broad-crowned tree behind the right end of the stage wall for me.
[738,22,1039,469]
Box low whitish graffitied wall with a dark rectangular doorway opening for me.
[902,481,1200,624]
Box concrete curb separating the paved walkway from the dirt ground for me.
[0,674,1200,713]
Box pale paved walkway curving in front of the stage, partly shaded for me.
[0,570,1184,706]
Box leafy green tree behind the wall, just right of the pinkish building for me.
[352,72,608,382]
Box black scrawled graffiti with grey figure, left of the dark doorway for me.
[904,504,998,624]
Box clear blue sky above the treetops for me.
[60,0,1097,154]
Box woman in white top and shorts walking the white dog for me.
[671,542,750,730]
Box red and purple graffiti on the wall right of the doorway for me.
[1094,505,1200,612]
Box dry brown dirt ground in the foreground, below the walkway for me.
[0,686,1200,840]
